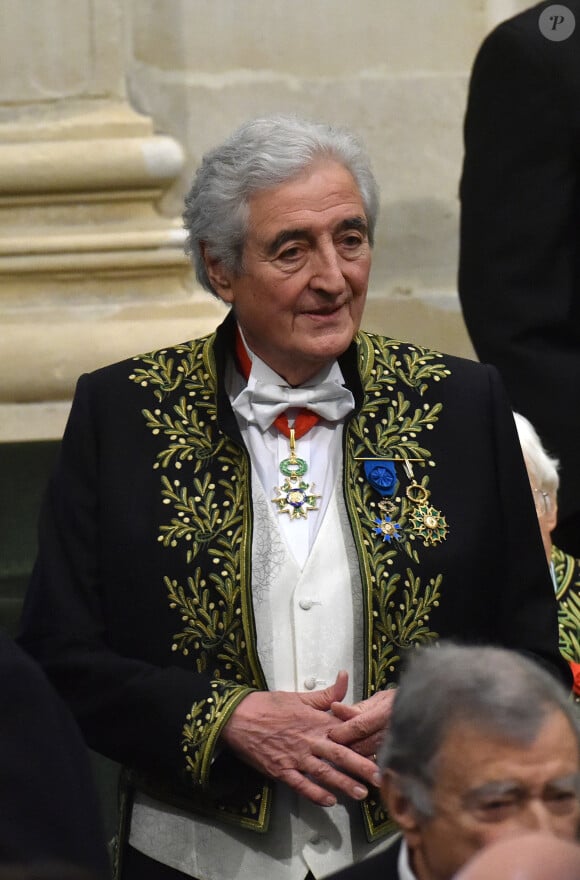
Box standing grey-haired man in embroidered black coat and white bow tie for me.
[20,116,569,880]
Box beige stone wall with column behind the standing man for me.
[0,0,528,439]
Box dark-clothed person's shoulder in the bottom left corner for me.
[0,630,110,880]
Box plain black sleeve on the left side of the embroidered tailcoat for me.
[19,377,249,787]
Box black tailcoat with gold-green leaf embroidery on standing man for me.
[21,315,566,839]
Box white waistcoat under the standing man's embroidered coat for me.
[130,479,386,880]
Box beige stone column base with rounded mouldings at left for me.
[0,0,222,440]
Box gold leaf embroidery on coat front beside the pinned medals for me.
[344,333,450,839]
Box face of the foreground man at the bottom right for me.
[383,711,580,880]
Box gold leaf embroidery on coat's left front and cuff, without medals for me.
[129,335,270,830]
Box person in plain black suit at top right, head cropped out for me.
[459,0,580,557]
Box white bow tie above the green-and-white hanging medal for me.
[232,380,354,431]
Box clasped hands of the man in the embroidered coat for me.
[222,671,395,807]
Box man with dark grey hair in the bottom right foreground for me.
[331,642,580,880]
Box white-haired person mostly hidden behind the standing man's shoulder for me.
[514,413,580,697]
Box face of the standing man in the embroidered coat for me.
[206,161,371,385]
